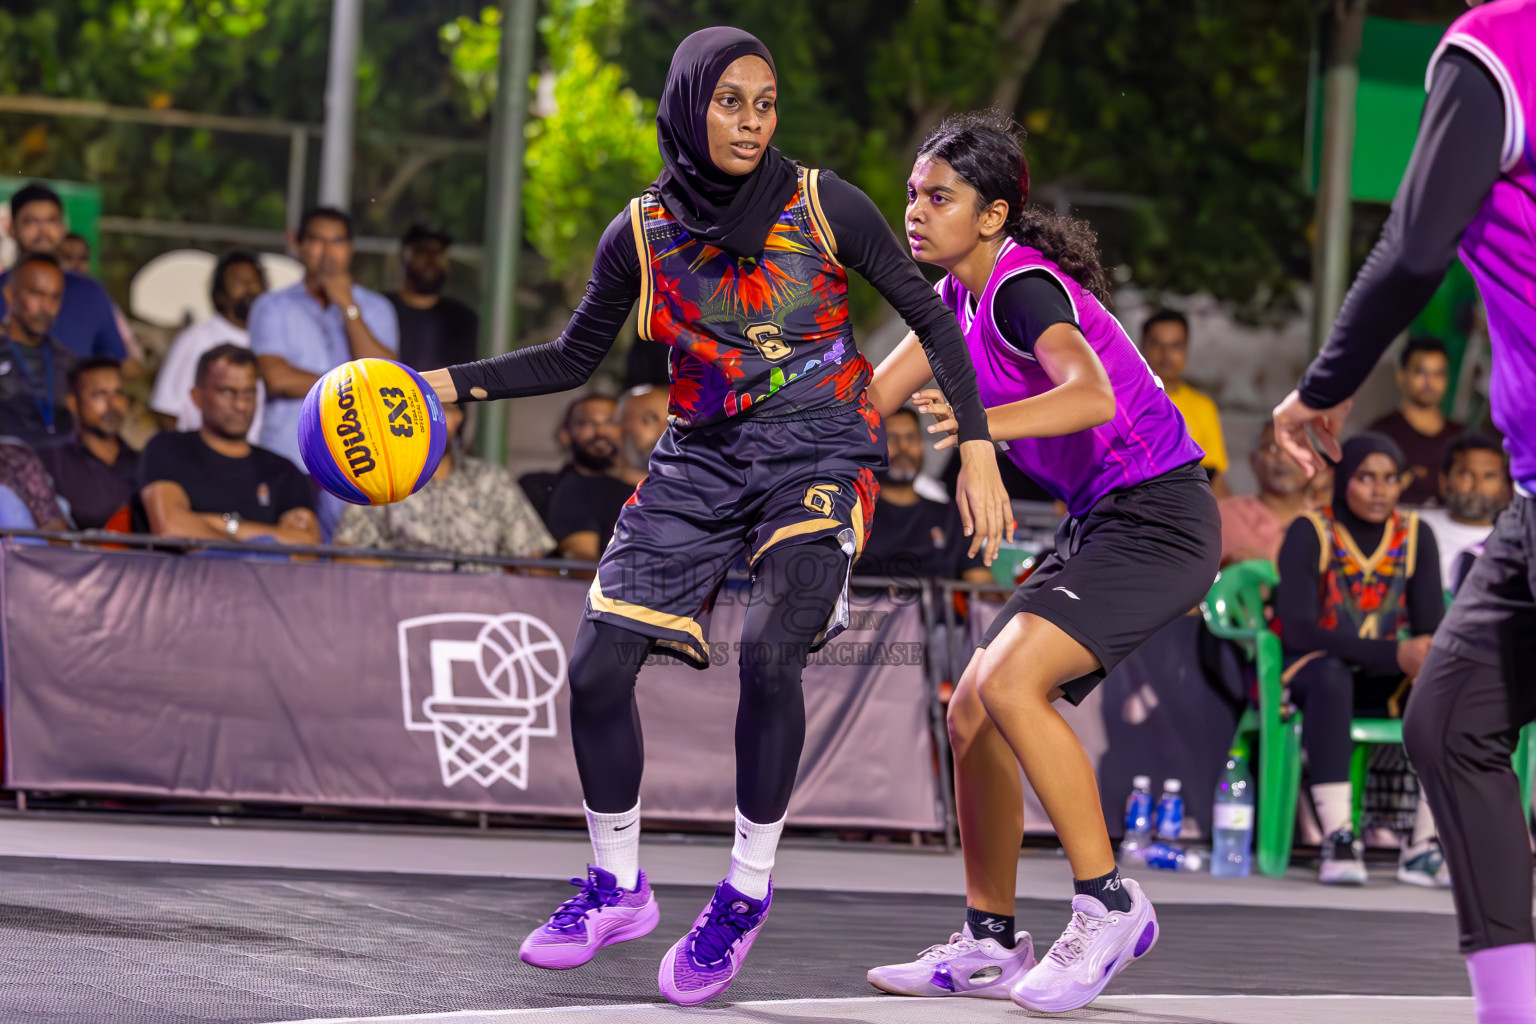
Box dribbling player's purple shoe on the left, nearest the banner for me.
[518,867,660,970]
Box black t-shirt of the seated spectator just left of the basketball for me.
[138,430,315,527]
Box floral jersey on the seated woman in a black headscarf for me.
[1303,511,1419,640]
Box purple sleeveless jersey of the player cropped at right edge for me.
[1425,0,1536,491]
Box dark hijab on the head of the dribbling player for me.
[651,26,796,259]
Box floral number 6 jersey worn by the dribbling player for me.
[630,167,874,427]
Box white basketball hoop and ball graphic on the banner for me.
[398,611,565,789]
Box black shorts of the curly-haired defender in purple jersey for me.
[980,462,1221,705]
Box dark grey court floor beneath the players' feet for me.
[0,853,1470,1024]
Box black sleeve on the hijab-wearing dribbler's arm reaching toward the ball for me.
[449,209,641,402]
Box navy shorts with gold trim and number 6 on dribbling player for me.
[587,404,886,668]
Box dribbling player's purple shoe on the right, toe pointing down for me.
[656,881,773,1006]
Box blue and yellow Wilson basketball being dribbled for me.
[298,359,449,505]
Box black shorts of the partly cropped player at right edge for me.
[1435,494,1536,693]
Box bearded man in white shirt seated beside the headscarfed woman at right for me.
[1419,430,1513,591]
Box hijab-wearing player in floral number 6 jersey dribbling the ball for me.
[427,28,1011,1006]
